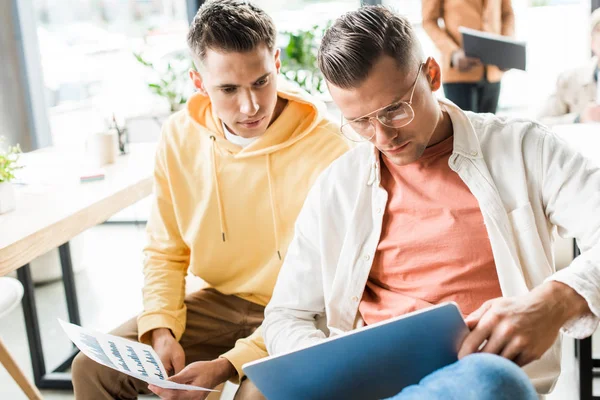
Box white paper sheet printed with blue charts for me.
[58,319,214,392]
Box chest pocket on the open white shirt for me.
[508,203,554,288]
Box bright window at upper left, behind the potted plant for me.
[34,0,188,144]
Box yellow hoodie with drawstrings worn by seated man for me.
[138,82,348,377]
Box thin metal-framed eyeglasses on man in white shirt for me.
[340,63,424,142]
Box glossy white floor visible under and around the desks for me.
[0,225,600,400]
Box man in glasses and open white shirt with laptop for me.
[263,7,600,400]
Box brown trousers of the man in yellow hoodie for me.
[72,289,264,400]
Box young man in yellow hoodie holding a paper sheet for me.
[73,0,347,399]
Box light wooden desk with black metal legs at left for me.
[0,144,156,389]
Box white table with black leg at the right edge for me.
[552,124,600,400]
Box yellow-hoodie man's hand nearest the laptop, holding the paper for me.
[148,358,237,400]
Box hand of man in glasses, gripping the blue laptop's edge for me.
[458,281,590,366]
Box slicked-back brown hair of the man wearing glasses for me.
[318,6,423,89]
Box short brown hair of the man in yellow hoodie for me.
[187,0,277,62]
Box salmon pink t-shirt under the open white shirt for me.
[359,136,502,324]
